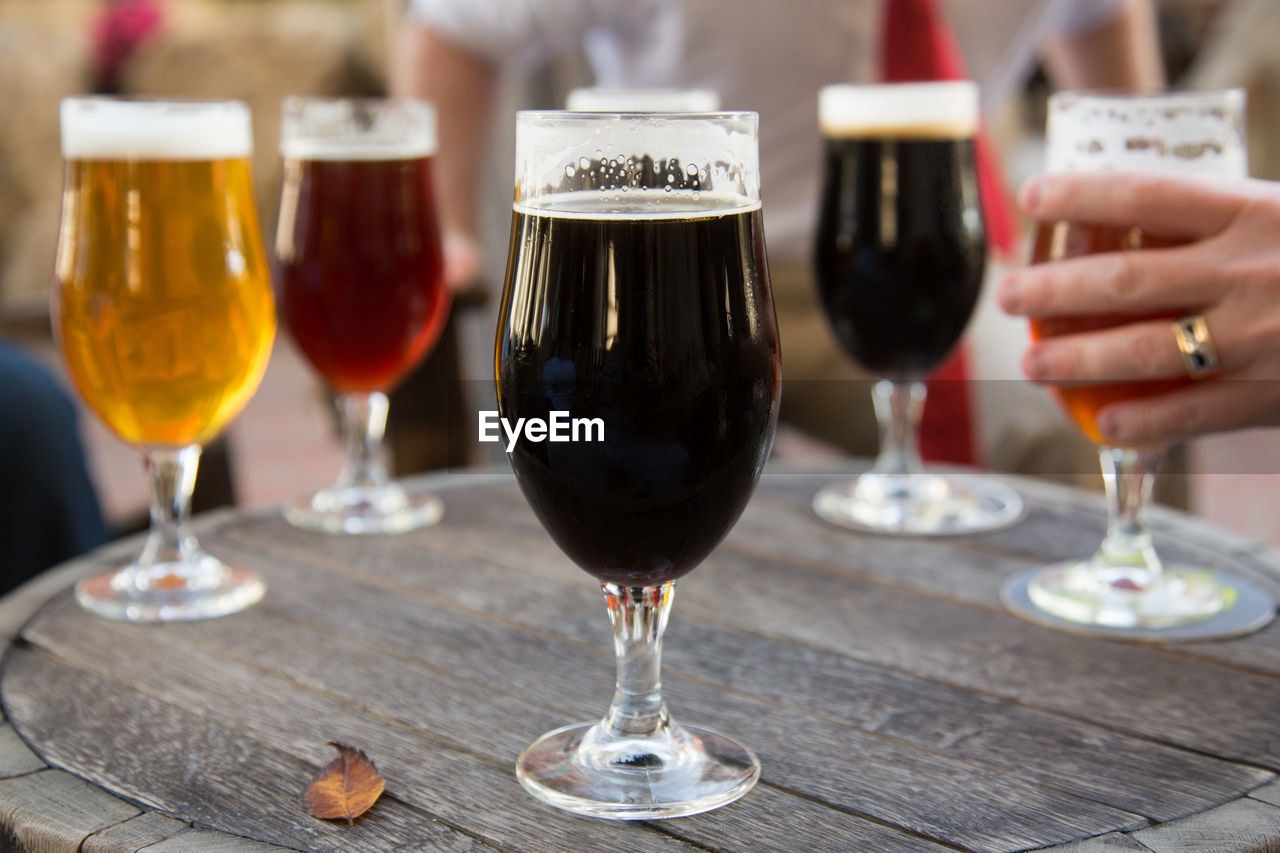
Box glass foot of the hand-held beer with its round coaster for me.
[1000,562,1276,643]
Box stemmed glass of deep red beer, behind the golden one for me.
[275,97,449,534]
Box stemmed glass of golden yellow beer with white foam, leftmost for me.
[50,97,275,621]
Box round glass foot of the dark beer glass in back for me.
[813,473,1023,537]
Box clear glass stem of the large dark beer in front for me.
[602,581,676,738]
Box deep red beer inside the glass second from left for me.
[276,156,449,392]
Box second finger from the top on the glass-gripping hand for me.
[996,246,1225,318]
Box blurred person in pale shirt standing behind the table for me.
[390,0,1167,489]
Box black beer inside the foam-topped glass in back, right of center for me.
[814,128,986,379]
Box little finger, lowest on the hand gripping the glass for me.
[1098,378,1280,444]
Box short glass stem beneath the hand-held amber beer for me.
[1094,447,1165,578]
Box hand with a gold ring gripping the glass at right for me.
[997,173,1280,444]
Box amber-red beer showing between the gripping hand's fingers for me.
[1030,222,1190,446]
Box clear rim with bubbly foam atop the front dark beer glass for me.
[515,110,760,218]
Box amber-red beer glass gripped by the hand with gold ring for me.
[1006,90,1247,633]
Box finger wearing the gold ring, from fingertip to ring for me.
[1023,320,1187,384]
